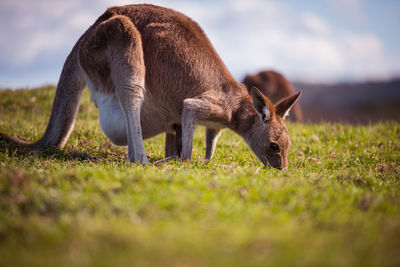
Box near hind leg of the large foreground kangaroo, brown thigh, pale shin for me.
[81,15,148,164]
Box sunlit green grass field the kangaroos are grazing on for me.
[0,87,400,266]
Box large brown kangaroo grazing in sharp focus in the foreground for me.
[2,5,300,168]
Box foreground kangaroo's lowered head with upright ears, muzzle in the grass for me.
[246,87,301,172]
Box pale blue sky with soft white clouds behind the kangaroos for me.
[0,0,400,88]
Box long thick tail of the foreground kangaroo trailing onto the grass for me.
[0,38,85,149]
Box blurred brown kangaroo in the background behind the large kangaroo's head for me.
[243,70,303,122]
